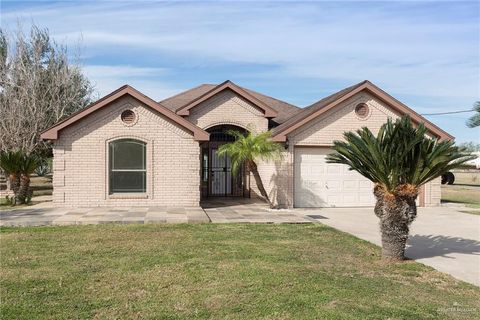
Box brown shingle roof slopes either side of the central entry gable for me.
[160,84,301,123]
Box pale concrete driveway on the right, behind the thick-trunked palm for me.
[305,207,480,286]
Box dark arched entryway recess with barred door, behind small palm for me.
[201,125,250,198]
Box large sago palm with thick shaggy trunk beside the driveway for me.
[327,116,473,260]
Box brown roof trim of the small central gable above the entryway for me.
[177,80,278,118]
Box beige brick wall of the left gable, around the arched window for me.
[53,97,200,206]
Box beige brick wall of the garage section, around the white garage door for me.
[262,92,441,207]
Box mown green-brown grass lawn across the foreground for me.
[0,224,480,319]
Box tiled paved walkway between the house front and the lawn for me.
[0,198,317,226]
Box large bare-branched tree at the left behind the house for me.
[0,24,93,154]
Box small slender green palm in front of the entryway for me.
[218,130,282,206]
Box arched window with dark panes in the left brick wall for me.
[108,139,147,194]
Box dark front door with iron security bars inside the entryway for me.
[210,148,232,196]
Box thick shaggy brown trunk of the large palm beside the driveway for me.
[375,188,417,260]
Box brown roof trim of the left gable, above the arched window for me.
[40,85,209,141]
